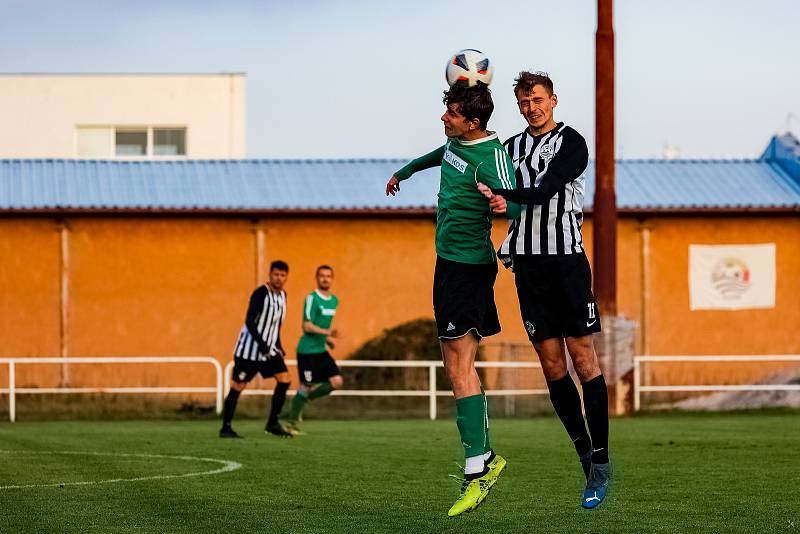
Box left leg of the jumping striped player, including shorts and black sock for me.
[514,258,591,477]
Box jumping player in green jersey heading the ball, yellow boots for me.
[386,83,519,517]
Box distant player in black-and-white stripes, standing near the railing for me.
[219,260,293,438]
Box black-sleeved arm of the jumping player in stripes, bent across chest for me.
[491,131,589,205]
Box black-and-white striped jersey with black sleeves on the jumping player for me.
[492,122,589,266]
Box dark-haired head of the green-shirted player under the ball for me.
[442,82,494,137]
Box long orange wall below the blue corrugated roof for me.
[0,217,800,394]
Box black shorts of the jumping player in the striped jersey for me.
[514,253,600,341]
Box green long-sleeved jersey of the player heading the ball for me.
[394,132,519,264]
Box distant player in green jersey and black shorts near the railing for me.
[285,265,343,435]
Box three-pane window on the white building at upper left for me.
[75,125,186,158]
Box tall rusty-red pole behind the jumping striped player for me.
[592,0,617,317]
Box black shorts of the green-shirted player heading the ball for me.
[433,257,500,339]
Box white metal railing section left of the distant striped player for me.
[0,356,222,423]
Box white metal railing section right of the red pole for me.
[633,354,800,411]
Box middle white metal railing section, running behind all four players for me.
[225,360,548,420]
